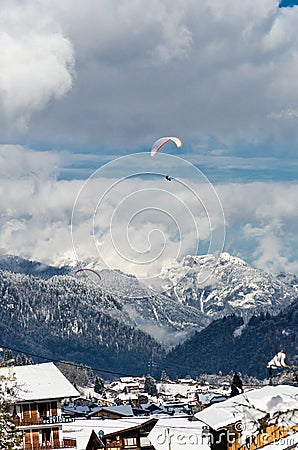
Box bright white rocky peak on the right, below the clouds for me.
[160,253,298,319]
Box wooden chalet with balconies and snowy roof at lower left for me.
[0,363,79,450]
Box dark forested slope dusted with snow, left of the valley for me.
[0,270,164,374]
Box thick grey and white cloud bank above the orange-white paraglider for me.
[0,0,298,154]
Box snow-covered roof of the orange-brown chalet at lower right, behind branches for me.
[195,385,298,431]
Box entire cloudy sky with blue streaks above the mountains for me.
[0,0,298,278]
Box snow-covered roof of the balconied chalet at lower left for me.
[0,362,80,401]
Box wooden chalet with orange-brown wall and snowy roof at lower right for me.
[195,385,298,450]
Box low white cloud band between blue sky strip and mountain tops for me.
[0,146,298,277]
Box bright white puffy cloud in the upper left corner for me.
[0,1,74,130]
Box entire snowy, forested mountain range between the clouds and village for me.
[0,254,298,375]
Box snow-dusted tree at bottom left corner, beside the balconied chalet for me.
[0,376,23,450]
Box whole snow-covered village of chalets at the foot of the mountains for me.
[0,362,298,450]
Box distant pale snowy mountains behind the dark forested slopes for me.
[0,253,298,345]
